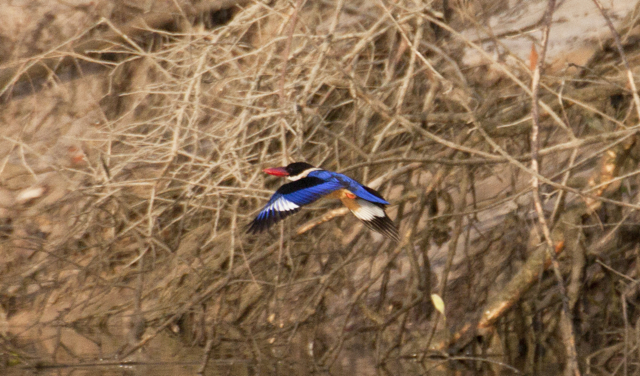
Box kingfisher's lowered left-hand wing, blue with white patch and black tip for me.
[247,177,342,234]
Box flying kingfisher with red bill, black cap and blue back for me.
[247,162,400,242]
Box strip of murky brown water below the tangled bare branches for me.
[0,327,514,376]
